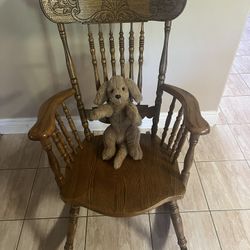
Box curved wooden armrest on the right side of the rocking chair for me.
[160,84,210,135]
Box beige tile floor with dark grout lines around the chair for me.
[0,18,250,250]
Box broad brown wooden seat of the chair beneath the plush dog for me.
[61,134,185,217]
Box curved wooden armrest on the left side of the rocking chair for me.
[28,89,75,141]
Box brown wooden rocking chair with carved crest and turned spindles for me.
[29,0,209,250]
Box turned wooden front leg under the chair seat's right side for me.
[169,201,187,250]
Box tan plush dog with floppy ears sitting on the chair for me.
[90,76,143,169]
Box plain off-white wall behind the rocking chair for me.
[0,0,249,119]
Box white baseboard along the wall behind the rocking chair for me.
[0,111,218,134]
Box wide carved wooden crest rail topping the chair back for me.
[40,0,186,23]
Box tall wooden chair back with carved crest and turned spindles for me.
[40,0,186,138]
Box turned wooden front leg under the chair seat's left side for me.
[64,206,80,250]
